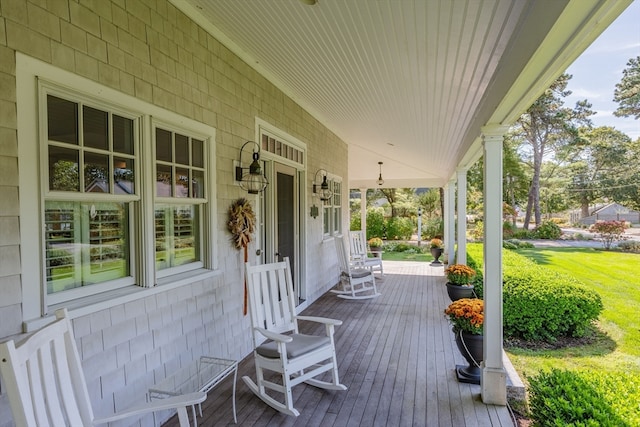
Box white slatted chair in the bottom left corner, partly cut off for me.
[0,309,207,427]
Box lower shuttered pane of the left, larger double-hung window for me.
[45,201,130,294]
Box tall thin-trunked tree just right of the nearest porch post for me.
[512,73,594,229]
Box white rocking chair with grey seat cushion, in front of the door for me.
[242,258,347,416]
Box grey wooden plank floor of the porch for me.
[165,261,514,427]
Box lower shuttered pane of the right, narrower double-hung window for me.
[155,205,200,270]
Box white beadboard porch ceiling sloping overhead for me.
[171,0,631,188]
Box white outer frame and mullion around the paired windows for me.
[16,52,221,331]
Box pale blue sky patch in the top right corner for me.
[565,0,640,140]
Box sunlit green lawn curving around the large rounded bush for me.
[507,248,640,376]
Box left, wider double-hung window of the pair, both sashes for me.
[43,93,138,301]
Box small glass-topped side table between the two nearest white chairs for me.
[149,356,238,427]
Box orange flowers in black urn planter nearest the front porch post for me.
[444,298,484,384]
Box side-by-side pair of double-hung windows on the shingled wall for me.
[27,78,215,310]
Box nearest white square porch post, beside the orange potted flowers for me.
[480,125,507,405]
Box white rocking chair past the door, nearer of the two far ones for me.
[331,236,380,299]
